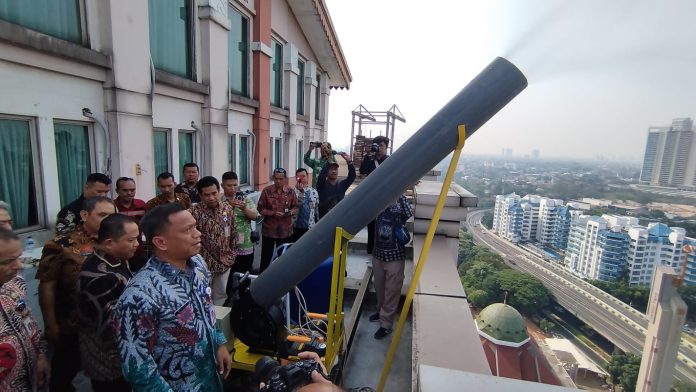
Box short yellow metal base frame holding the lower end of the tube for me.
[231,227,355,372]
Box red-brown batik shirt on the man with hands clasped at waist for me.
[258,185,298,239]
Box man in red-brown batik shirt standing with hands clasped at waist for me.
[257,167,299,273]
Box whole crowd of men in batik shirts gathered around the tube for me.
[0,138,412,391]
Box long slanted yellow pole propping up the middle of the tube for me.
[377,125,466,392]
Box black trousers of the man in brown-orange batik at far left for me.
[48,335,82,392]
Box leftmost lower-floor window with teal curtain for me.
[0,118,41,231]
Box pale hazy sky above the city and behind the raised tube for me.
[325,0,696,161]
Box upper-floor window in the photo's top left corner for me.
[0,0,84,44]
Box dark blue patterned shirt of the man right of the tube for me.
[372,195,413,261]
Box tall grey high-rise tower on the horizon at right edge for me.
[640,118,696,190]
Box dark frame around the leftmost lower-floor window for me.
[0,113,48,234]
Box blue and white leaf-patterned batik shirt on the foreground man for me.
[112,256,226,392]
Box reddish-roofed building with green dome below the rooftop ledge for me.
[476,303,561,385]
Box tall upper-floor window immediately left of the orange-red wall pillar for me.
[227,7,249,97]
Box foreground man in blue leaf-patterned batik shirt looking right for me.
[113,203,231,392]
